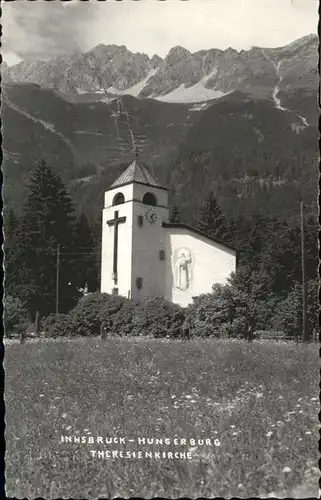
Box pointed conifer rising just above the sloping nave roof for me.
[197,191,228,240]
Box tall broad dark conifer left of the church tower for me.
[17,161,79,321]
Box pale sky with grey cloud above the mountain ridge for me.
[1,0,318,64]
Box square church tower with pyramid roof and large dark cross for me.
[101,153,169,300]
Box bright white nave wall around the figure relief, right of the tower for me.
[165,228,236,306]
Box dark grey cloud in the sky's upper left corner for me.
[2,0,92,59]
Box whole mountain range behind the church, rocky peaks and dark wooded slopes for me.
[2,35,318,223]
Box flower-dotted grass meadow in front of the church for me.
[5,339,319,498]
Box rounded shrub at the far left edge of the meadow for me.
[4,295,28,337]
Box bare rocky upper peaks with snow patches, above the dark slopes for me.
[3,35,318,102]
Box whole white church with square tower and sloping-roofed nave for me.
[101,154,237,307]
